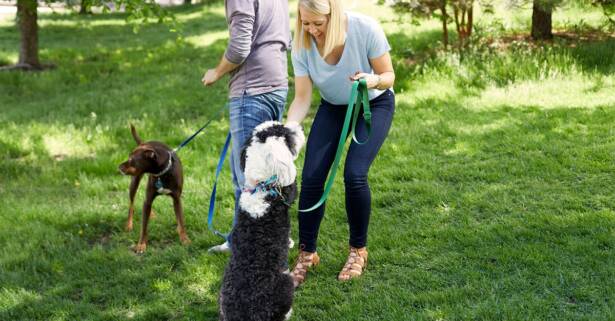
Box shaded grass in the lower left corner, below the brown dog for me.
[0,195,227,320]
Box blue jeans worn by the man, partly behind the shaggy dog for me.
[229,89,288,235]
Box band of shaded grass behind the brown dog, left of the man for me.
[0,34,227,125]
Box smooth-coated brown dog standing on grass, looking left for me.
[119,124,190,253]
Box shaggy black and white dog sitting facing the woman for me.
[219,121,305,321]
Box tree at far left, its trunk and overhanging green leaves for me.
[0,0,173,70]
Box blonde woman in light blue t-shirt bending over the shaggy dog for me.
[287,0,395,286]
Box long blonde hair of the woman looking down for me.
[293,0,346,58]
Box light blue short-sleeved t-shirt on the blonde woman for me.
[291,12,391,105]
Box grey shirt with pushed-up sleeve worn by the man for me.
[224,0,290,97]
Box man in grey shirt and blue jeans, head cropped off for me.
[202,0,290,252]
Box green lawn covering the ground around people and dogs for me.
[0,1,615,321]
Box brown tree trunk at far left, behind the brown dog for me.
[17,0,42,69]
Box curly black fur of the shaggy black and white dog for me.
[219,126,297,321]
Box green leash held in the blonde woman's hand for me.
[299,79,372,212]
